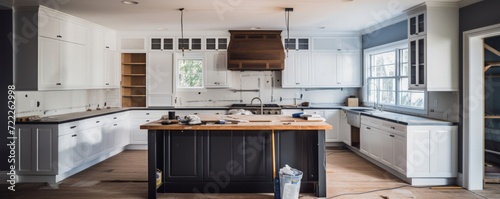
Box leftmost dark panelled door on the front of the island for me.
[164,130,202,182]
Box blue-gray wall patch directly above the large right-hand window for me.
[361,20,408,50]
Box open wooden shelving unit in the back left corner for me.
[121,53,146,107]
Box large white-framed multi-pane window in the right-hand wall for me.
[365,41,426,110]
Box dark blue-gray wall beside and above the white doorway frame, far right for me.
[458,0,500,172]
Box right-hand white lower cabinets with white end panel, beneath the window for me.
[360,116,458,185]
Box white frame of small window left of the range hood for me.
[174,52,206,92]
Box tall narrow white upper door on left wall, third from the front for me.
[88,30,107,88]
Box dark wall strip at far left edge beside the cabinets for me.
[0,6,13,171]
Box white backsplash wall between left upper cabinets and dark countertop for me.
[16,89,120,117]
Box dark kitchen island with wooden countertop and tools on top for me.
[141,115,332,198]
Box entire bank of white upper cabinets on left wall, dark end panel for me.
[14,6,118,91]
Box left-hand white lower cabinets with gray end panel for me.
[16,113,129,186]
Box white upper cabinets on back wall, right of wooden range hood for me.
[282,37,362,88]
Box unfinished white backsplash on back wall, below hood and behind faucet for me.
[175,71,357,106]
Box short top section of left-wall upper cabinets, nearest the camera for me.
[38,10,87,44]
